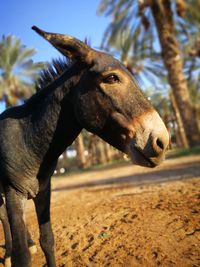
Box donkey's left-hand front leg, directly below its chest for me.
[5,187,31,267]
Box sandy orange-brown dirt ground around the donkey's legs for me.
[0,156,200,267]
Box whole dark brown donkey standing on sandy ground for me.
[0,26,169,267]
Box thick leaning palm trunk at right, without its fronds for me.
[151,0,200,146]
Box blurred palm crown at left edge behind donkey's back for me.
[0,35,44,107]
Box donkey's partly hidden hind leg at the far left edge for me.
[0,195,12,267]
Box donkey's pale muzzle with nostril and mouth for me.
[128,111,169,167]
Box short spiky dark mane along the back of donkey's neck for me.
[35,57,72,92]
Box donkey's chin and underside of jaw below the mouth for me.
[127,147,164,168]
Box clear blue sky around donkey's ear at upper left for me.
[0,0,109,61]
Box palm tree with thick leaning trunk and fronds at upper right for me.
[99,0,200,146]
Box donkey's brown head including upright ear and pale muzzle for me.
[33,27,169,167]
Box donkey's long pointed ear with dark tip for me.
[32,26,94,65]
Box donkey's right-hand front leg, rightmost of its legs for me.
[34,184,56,267]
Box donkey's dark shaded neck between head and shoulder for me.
[26,63,81,160]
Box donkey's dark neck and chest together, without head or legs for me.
[0,61,82,198]
